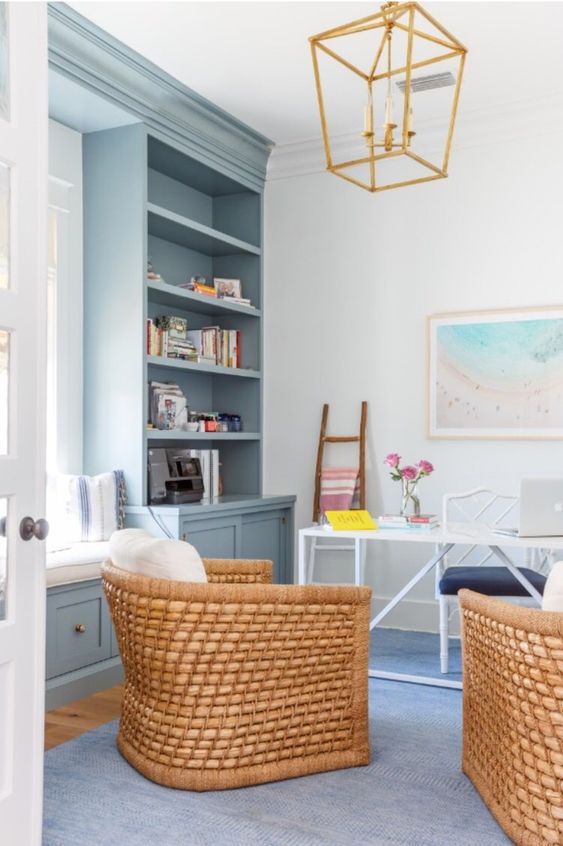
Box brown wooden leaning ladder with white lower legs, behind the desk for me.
[307,400,368,585]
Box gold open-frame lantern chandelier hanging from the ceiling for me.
[309,2,467,192]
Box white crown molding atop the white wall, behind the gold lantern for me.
[267,93,563,181]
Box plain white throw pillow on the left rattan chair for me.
[109,529,207,582]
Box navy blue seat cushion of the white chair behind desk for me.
[439,567,546,596]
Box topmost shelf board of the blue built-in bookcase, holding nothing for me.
[147,203,261,257]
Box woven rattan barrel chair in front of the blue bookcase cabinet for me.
[102,560,371,790]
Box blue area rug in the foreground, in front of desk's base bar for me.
[43,680,511,846]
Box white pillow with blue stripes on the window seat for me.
[56,470,125,543]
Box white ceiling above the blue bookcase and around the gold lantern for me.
[71,0,563,144]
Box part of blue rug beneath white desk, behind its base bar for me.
[369,627,461,681]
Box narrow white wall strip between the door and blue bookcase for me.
[49,120,82,473]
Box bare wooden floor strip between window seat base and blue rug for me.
[45,685,122,749]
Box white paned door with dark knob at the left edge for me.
[0,2,48,846]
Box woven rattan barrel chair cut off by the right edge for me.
[459,590,563,846]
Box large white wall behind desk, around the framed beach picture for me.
[264,132,563,629]
